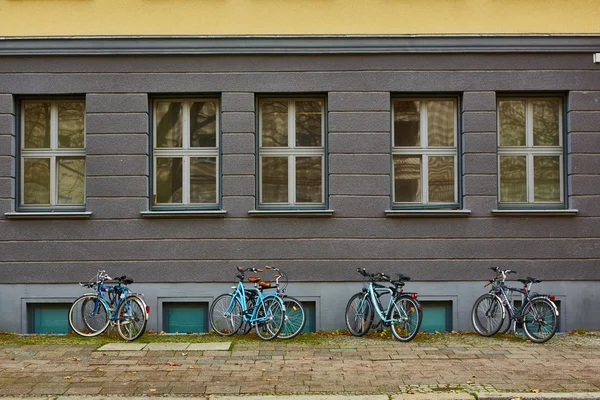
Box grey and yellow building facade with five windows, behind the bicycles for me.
[0,0,600,333]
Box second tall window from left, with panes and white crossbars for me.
[152,99,220,208]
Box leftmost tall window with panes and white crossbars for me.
[19,100,86,209]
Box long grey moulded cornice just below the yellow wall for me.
[0,35,600,55]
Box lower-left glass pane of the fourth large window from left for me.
[394,156,421,203]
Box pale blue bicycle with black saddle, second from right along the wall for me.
[345,268,423,342]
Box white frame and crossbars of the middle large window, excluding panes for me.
[258,97,326,208]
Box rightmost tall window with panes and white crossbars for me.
[498,97,564,206]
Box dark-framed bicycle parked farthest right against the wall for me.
[471,267,559,343]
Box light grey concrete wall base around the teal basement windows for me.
[0,282,600,333]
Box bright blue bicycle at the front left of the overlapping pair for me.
[209,267,285,340]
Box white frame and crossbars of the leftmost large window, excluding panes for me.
[19,98,87,209]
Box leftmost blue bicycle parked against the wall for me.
[69,270,150,341]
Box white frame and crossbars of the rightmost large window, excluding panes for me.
[496,97,565,206]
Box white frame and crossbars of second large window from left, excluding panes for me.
[152,98,221,209]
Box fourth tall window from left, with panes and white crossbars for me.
[392,98,458,208]
